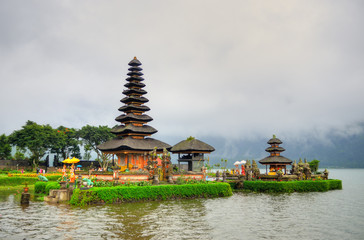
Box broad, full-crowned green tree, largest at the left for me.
[9,120,55,167]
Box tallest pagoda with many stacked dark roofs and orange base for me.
[98,57,171,169]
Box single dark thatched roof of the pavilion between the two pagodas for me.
[170,139,215,153]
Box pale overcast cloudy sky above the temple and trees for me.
[0,0,364,144]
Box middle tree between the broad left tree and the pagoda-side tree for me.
[51,126,81,159]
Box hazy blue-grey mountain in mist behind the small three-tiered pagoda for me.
[165,124,364,168]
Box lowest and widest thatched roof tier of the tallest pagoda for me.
[97,137,171,151]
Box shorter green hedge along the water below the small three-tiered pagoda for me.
[244,179,342,192]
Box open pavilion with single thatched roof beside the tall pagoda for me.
[170,137,215,172]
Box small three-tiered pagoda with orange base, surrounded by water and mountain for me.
[259,135,292,175]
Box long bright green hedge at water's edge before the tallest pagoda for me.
[70,183,232,206]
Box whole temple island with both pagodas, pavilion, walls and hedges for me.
[40,57,341,204]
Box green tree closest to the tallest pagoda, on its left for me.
[79,125,114,168]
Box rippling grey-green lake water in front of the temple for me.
[0,169,364,240]
